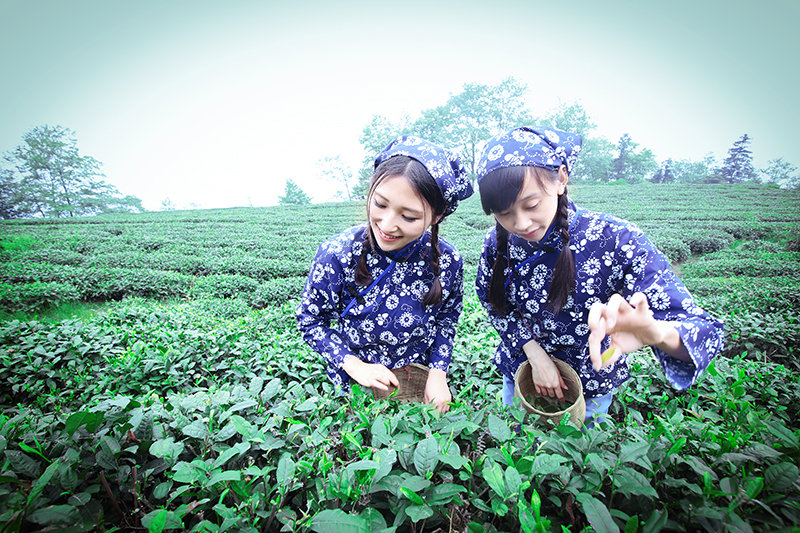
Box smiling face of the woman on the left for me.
[368,175,433,252]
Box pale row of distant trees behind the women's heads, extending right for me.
[353,78,800,188]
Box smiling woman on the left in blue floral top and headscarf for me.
[297,136,472,413]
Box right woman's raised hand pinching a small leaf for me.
[588,292,661,370]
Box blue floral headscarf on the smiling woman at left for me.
[375,135,473,218]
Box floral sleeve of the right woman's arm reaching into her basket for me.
[475,229,534,354]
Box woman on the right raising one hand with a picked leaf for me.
[476,127,723,423]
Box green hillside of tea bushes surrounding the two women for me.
[0,184,800,532]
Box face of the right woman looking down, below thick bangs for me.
[493,166,567,242]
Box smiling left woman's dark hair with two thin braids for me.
[356,155,447,305]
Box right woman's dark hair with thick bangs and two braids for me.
[480,166,575,313]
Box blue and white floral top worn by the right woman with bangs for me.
[476,201,723,398]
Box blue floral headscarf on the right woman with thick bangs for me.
[477,127,583,183]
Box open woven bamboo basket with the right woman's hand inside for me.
[514,357,586,427]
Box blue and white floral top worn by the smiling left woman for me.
[297,225,464,390]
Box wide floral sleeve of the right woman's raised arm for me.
[616,224,723,389]
